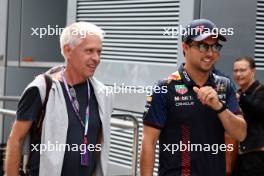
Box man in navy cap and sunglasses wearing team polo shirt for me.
[140,19,246,176]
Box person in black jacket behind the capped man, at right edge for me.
[232,57,264,176]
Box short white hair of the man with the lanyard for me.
[60,22,104,60]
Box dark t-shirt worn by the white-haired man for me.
[17,82,102,176]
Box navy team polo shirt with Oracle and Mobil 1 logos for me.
[143,65,241,176]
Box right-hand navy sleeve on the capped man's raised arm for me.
[226,80,242,115]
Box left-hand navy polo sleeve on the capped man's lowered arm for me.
[143,82,168,129]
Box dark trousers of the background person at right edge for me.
[232,151,264,176]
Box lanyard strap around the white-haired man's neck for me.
[61,68,90,137]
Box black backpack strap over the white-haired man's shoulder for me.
[24,74,52,176]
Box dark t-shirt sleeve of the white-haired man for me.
[16,87,42,121]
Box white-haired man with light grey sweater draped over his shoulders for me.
[5,22,113,176]
